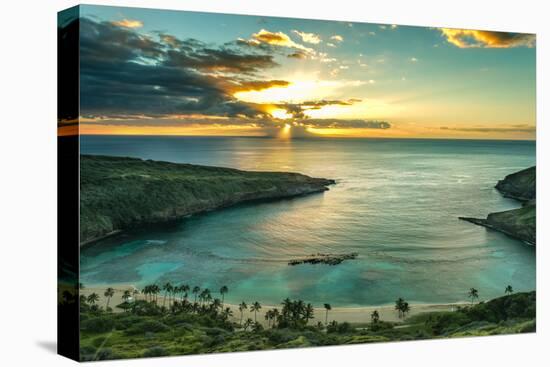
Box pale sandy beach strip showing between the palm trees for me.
[80,285,469,325]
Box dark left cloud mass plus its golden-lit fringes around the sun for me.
[70,18,370,135]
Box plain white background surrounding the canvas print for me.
[0,0,550,367]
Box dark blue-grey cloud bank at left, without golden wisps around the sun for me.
[80,18,285,117]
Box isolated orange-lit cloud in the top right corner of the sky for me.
[440,28,536,48]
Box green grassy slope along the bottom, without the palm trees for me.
[81,292,536,360]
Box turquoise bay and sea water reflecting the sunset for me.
[81,136,535,306]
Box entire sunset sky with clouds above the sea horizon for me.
[60,6,536,139]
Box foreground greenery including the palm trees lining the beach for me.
[62,285,536,361]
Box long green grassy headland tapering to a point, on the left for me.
[80,155,334,243]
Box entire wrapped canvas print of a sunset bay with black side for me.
[58,5,536,361]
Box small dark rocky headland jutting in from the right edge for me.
[459,167,537,246]
